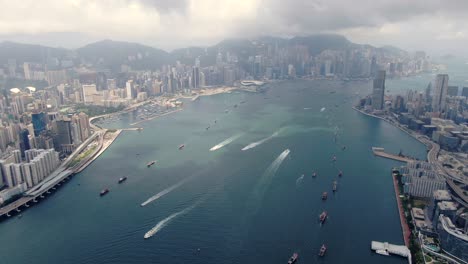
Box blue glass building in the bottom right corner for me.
[437,215,468,262]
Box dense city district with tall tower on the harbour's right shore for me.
[355,70,468,263]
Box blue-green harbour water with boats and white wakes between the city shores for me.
[0,77,426,264]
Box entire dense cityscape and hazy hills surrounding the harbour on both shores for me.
[0,35,468,263]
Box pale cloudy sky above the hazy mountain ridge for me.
[0,0,468,54]
